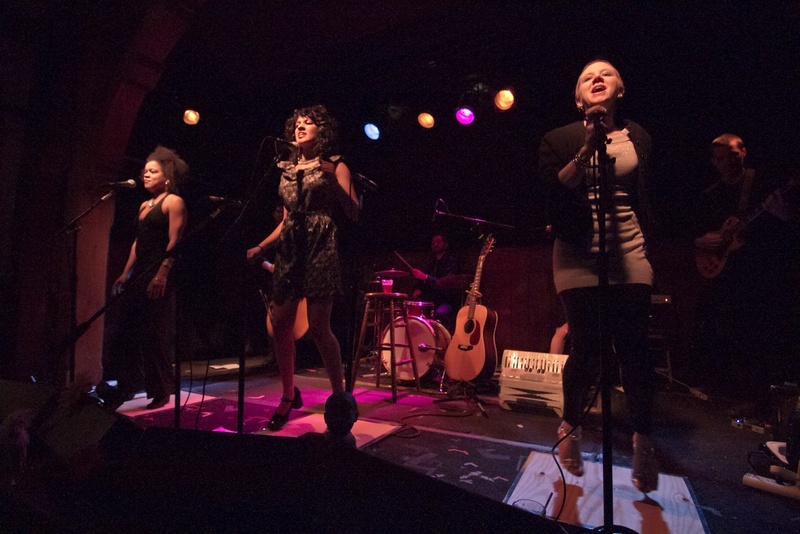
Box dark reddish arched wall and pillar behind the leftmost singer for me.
[6,0,205,385]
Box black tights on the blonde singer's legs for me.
[559,284,655,434]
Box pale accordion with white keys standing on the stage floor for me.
[499,350,600,417]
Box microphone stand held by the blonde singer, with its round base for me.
[591,119,635,534]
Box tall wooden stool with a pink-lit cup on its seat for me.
[351,293,420,402]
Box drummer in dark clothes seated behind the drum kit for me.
[411,233,461,333]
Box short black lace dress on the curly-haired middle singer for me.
[273,156,342,304]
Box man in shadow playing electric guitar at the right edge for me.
[694,133,800,417]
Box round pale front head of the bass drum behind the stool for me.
[381,316,437,383]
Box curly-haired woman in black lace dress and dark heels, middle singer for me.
[247,105,359,430]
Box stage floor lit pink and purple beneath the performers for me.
[120,362,800,533]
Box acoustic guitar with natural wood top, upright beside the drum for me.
[444,235,497,382]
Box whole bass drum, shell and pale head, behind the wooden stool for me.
[381,316,450,384]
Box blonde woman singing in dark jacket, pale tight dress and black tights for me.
[539,61,658,493]
